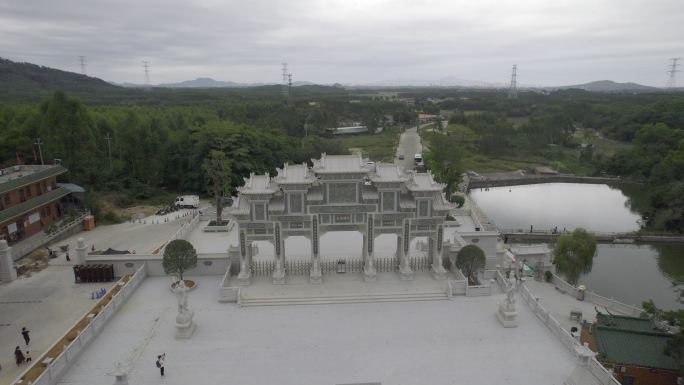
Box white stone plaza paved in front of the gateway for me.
[60,277,576,385]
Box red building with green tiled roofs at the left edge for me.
[0,165,71,246]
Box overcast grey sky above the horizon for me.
[0,0,684,87]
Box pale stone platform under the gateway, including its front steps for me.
[231,272,449,306]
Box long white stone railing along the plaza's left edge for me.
[13,264,147,385]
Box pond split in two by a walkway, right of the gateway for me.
[470,183,684,309]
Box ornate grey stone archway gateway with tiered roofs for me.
[228,154,453,285]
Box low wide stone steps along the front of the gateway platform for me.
[238,291,449,307]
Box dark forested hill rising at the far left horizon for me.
[0,58,121,101]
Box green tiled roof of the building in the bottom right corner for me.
[590,313,680,370]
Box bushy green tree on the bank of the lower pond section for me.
[553,228,596,286]
